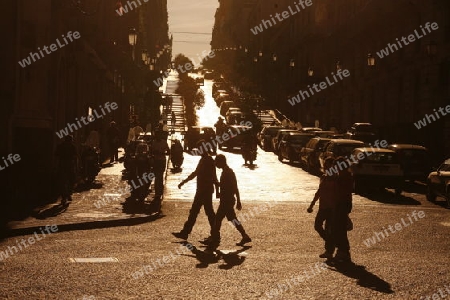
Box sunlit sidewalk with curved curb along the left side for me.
[6,72,185,236]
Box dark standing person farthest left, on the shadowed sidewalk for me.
[55,135,78,204]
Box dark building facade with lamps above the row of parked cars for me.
[213,0,450,159]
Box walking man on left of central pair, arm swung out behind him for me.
[172,140,219,239]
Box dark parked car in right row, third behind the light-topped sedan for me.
[278,132,314,163]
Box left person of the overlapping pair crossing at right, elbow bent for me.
[307,157,337,259]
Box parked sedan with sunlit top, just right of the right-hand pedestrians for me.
[351,148,403,195]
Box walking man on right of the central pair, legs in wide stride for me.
[209,154,252,249]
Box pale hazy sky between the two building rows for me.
[167,0,219,64]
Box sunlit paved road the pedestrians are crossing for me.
[0,73,450,299]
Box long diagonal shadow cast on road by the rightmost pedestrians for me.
[325,261,394,294]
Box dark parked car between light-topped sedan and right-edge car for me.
[388,144,431,182]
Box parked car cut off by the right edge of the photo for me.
[427,158,450,207]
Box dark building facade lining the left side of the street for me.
[0,0,171,213]
